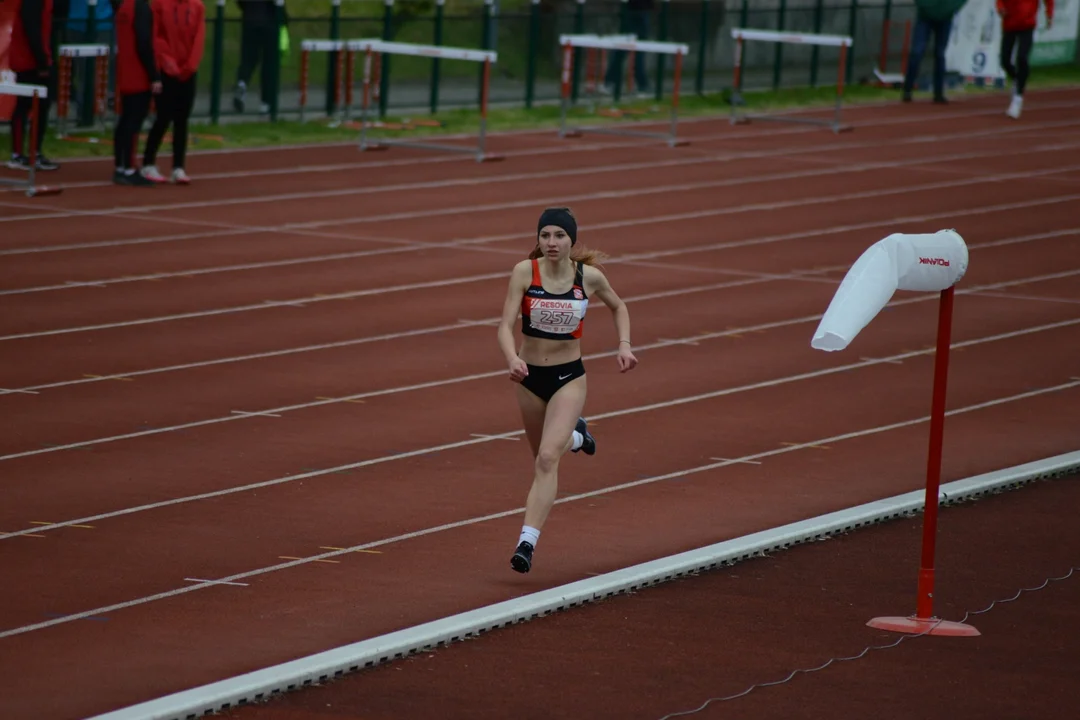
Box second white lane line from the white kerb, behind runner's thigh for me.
[0,316,1080,540]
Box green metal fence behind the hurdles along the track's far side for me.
[50,0,989,124]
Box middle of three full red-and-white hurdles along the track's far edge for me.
[558,35,690,148]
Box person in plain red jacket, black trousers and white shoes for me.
[143,0,206,185]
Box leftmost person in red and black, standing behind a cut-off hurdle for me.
[8,0,59,169]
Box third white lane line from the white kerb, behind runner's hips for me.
[0,269,1080,461]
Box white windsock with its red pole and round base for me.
[810,230,980,637]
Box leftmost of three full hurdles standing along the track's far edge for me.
[346,39,503,163]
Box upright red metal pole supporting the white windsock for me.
[916,286,953,620]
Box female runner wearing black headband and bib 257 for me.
[499,207,637,572]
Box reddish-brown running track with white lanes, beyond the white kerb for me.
[0,87,1080,718]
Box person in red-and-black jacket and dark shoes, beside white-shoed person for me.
[112,0,161,187]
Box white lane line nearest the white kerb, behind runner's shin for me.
[0,381,1080,639]
